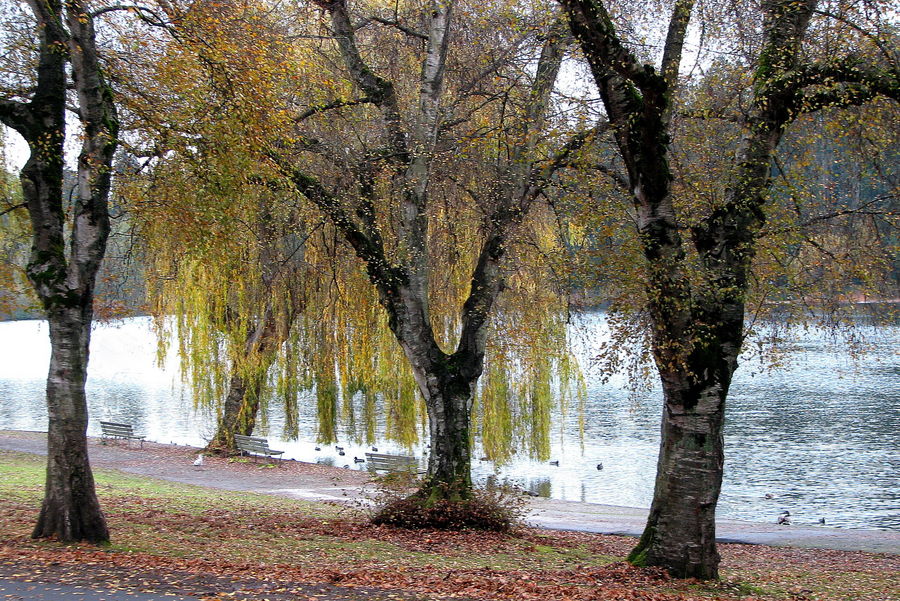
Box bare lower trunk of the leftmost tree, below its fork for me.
[32,302,109,543]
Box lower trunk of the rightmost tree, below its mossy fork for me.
[628,296,746,579]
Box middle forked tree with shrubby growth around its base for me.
[269,0,584,506]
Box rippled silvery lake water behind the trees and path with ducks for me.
[0,315,900,530]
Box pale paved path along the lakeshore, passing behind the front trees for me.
[0,431,900,554]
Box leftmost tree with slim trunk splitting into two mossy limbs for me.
[0,0,118,543]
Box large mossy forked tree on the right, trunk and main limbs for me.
[561,0,900,578]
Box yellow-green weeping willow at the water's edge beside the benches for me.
[118,2,428,452]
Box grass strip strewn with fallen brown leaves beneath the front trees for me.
[0,451,900,601]
